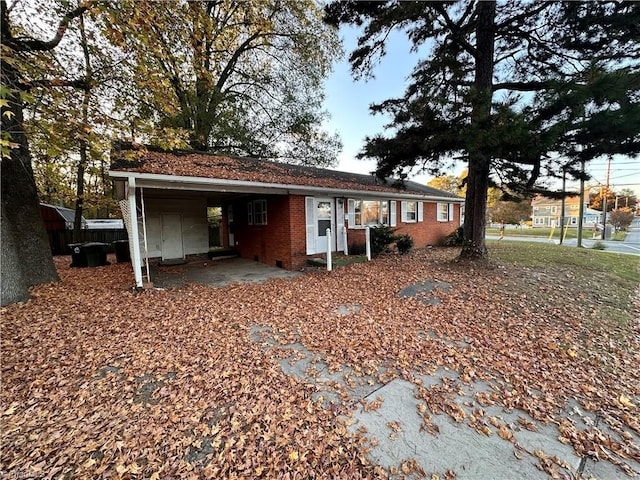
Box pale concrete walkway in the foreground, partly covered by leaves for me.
[249,324,640,480]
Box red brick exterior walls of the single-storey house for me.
[222,195,460,270]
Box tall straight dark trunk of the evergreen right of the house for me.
[460,1,496,259]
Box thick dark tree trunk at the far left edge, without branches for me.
[0,57,58,305]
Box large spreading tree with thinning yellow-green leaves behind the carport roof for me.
[105,0,340,165]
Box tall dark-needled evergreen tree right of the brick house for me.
[325,0,640,259]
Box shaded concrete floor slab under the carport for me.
[149,256,301,288]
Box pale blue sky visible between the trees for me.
[325,27,640,198]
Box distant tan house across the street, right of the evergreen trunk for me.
[531,195,602,228]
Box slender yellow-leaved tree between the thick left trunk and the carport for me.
[20,0,135,229]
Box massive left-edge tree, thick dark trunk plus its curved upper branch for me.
[0,0,88,305]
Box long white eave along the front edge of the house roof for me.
[108,170,464,203]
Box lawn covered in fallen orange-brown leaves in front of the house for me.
[0,247,640,479]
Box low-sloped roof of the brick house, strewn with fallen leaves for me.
[110,144,463,202]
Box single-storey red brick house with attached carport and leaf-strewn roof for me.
[109,147,464,286]
